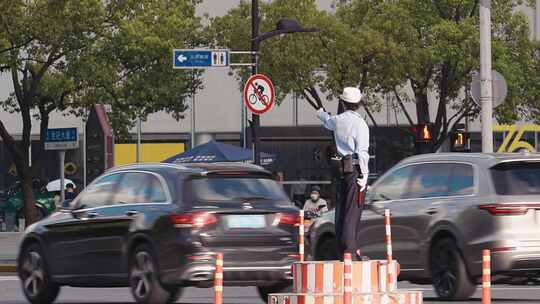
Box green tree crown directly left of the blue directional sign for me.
[74,0,205,137]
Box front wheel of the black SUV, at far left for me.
[17,244,60,304]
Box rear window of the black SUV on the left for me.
[187,177,288,202]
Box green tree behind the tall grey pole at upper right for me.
[352,0,534,151]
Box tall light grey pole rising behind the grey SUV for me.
[480,0,493,153]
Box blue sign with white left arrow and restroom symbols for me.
[173,49,229,69]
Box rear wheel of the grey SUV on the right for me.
[430,239,476,300]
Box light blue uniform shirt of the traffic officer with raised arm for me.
[317,108,369,174]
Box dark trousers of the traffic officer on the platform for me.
[335,170,364,260]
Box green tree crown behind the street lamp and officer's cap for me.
[211,0,410,125]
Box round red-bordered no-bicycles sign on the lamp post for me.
[244,74,276,114]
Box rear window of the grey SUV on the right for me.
[491,162,540,195]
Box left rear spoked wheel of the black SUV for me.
[129,244,176,304]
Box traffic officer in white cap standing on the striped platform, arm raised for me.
[317,87,369,259]
